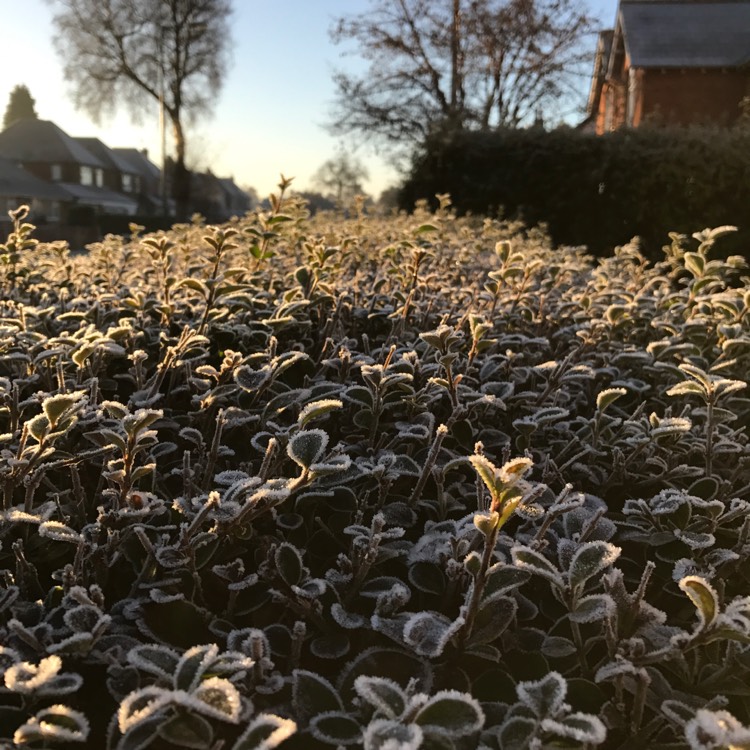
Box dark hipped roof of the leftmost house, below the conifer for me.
[0,118,106,167]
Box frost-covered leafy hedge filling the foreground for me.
[0,197,750,750]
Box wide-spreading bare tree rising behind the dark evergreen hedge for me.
[332,0,594,145]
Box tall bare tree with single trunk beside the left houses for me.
[52,0,232,218]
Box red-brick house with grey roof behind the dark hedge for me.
[584,0,750,134]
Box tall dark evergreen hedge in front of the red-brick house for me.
[400,128,750,257]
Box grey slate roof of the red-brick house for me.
[618,0,750,68]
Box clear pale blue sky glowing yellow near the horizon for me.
[0,0,617,198]
